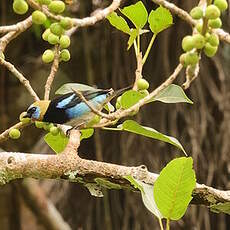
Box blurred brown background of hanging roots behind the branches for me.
[0,0,230,230]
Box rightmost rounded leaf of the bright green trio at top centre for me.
[148,6,173,34]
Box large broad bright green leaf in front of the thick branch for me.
[153,157,196,220]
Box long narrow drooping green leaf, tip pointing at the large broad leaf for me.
[121,120,187,155]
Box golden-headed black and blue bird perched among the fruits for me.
[24,86,130,127]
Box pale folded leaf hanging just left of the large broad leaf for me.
[125,175,163,219]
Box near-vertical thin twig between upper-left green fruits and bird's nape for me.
[44,45,60,100]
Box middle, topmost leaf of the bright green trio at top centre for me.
[120,1,148,29]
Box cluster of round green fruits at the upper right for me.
[180,0,228,66]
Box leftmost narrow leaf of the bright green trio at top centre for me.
[106,12,130,34]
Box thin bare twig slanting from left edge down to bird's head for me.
[0,58,39,101]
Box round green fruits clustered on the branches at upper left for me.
[13,0,72,63]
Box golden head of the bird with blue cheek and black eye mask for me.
[24,100,50,121]
